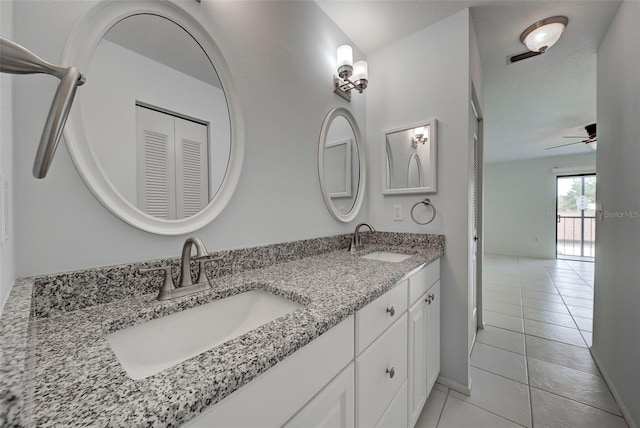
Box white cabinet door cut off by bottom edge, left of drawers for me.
[284,362,355,428]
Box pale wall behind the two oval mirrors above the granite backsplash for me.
[12,0,367,276]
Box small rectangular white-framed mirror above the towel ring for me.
[382,119,438,195]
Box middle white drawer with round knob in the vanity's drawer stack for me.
[356,313,407,427]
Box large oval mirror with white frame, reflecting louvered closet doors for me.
[63,0,244,235]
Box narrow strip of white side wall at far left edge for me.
[0,1,16,315]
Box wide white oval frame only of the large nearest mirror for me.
[62,0,244,235]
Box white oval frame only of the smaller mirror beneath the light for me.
[318,107,367,223]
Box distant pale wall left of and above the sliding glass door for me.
[484,152,599,259]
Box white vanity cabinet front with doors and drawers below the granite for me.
[185,260,440,427]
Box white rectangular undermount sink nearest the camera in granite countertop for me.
[106,290,302,380]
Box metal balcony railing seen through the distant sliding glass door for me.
[556,215,596,258]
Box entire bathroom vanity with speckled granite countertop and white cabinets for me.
[0,232,444,426]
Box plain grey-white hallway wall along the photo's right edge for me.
[592,0,640,428]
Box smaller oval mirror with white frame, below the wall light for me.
[318,107,366,223]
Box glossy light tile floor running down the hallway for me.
[416,255,627,428]
